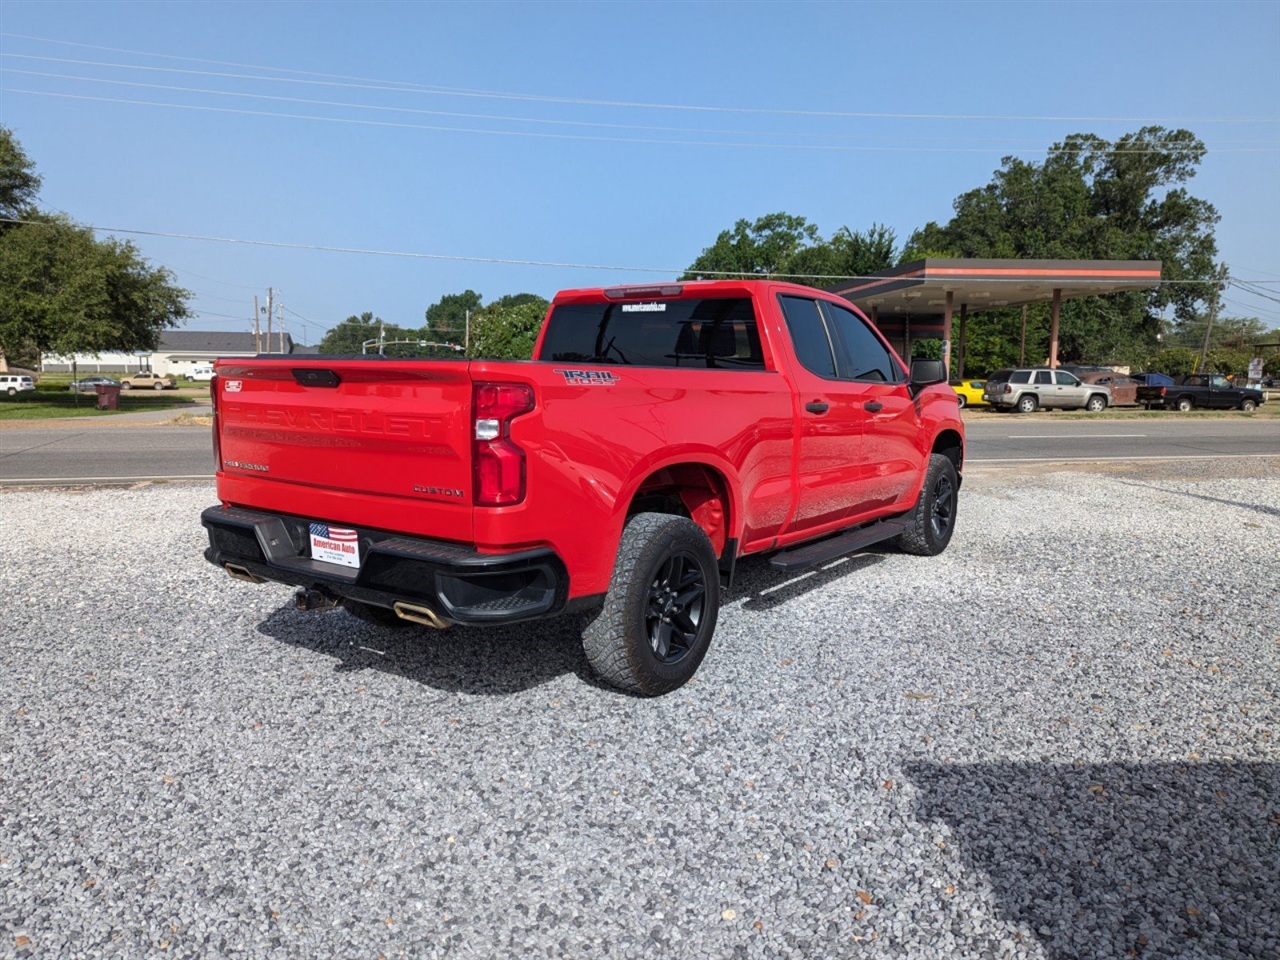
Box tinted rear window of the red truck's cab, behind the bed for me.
[541,297,764,370]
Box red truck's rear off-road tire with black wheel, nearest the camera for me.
[582,513,719,696]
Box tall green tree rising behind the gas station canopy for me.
[904,127,1219,369]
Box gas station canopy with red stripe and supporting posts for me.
[827,257,1160,376]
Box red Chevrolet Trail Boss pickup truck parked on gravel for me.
[202,280,964,695]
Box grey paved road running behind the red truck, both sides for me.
[0,413,1280,485]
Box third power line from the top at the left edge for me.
[0,62,1280,152]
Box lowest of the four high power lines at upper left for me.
[12,87,1280,154]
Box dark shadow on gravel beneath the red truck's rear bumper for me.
[257,607,604,695]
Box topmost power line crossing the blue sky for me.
[0,33,1280,123]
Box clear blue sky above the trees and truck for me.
[0,0,1280,342]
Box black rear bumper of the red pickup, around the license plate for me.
[200,506,568,625]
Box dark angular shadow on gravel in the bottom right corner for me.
[906,763,1280,960]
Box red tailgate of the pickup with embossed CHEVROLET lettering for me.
[216,357,472,540]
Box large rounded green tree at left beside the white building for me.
[0,211,191,357]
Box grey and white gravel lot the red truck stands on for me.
[0,461,1280,960]
